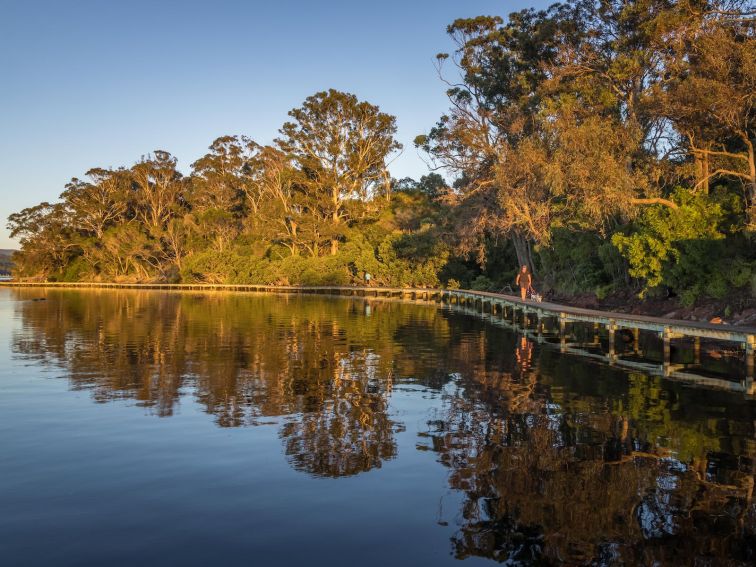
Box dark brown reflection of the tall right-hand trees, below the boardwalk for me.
[426,332,756,565]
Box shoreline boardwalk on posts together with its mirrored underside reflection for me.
[0,282,756,395]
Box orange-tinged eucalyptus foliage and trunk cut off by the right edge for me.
[658,7,756,223]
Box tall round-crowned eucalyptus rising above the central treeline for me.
[276,89,401,254]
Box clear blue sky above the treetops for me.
[0,0,550,248]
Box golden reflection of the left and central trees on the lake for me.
[14,290,448,477]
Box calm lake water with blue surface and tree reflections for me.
[0,289,756,567]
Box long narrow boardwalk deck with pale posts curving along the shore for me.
[0,281,756,393]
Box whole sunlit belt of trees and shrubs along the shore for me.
[8,0,756,303]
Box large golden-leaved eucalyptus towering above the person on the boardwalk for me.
[416,0,752,267]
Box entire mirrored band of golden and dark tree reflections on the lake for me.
[7,290,756,565]
